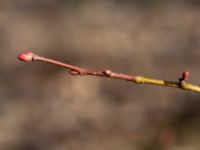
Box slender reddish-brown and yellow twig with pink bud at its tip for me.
[18,51,200,93]
